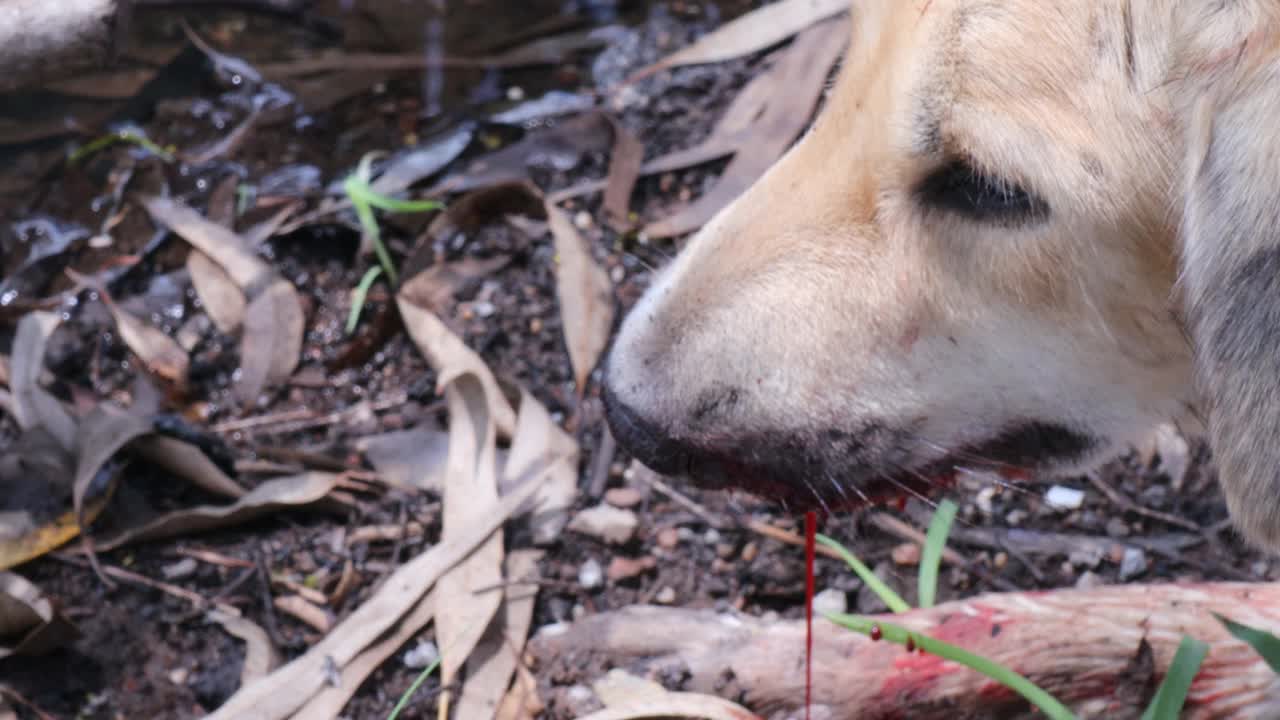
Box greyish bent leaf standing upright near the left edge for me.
[9,313,76,450]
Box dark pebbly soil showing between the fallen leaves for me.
[0,1,1277,719]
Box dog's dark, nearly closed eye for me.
[915,160,1048,223]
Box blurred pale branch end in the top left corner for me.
[0,0,118,92]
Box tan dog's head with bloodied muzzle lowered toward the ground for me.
[603,0,1280,550]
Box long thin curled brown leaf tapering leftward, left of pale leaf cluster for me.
[95,473,339,551]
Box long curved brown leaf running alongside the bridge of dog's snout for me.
[644,17,849,238]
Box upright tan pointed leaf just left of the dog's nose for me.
[547,202,613,395]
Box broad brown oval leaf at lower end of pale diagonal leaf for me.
[236,278,306,404]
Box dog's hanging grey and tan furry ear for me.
[1181,56,1280,550]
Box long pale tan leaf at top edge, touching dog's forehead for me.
[639,0,849,76]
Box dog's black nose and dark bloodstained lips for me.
[604,388,1098,512]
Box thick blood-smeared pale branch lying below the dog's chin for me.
[531,583,1280,720]
